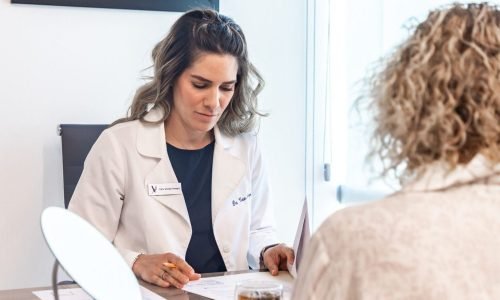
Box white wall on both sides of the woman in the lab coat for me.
[0,0,305,289]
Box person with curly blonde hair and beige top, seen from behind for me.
[294,3,500,299]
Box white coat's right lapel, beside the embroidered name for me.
[212,126,246,220]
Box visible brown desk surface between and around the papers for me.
[0,270,258,300]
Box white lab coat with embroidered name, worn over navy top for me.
[69,109,277,271]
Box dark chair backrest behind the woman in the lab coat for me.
[59,124,108,208]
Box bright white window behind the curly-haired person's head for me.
[306,0,494,228]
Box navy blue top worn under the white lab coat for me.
[167,142,226,273]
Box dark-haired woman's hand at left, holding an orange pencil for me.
[132,252,201,289]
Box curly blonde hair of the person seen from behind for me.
[370,3,500,181]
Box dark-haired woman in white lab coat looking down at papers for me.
[69,10,294,288]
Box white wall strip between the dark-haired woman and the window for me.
[220,0,306,245]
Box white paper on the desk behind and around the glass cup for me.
[183,271,293,300]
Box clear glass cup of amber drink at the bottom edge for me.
[234,280,283,300]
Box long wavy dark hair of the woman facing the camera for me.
[113,9,264,136]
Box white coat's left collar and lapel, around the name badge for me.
[137,109,190,224]
